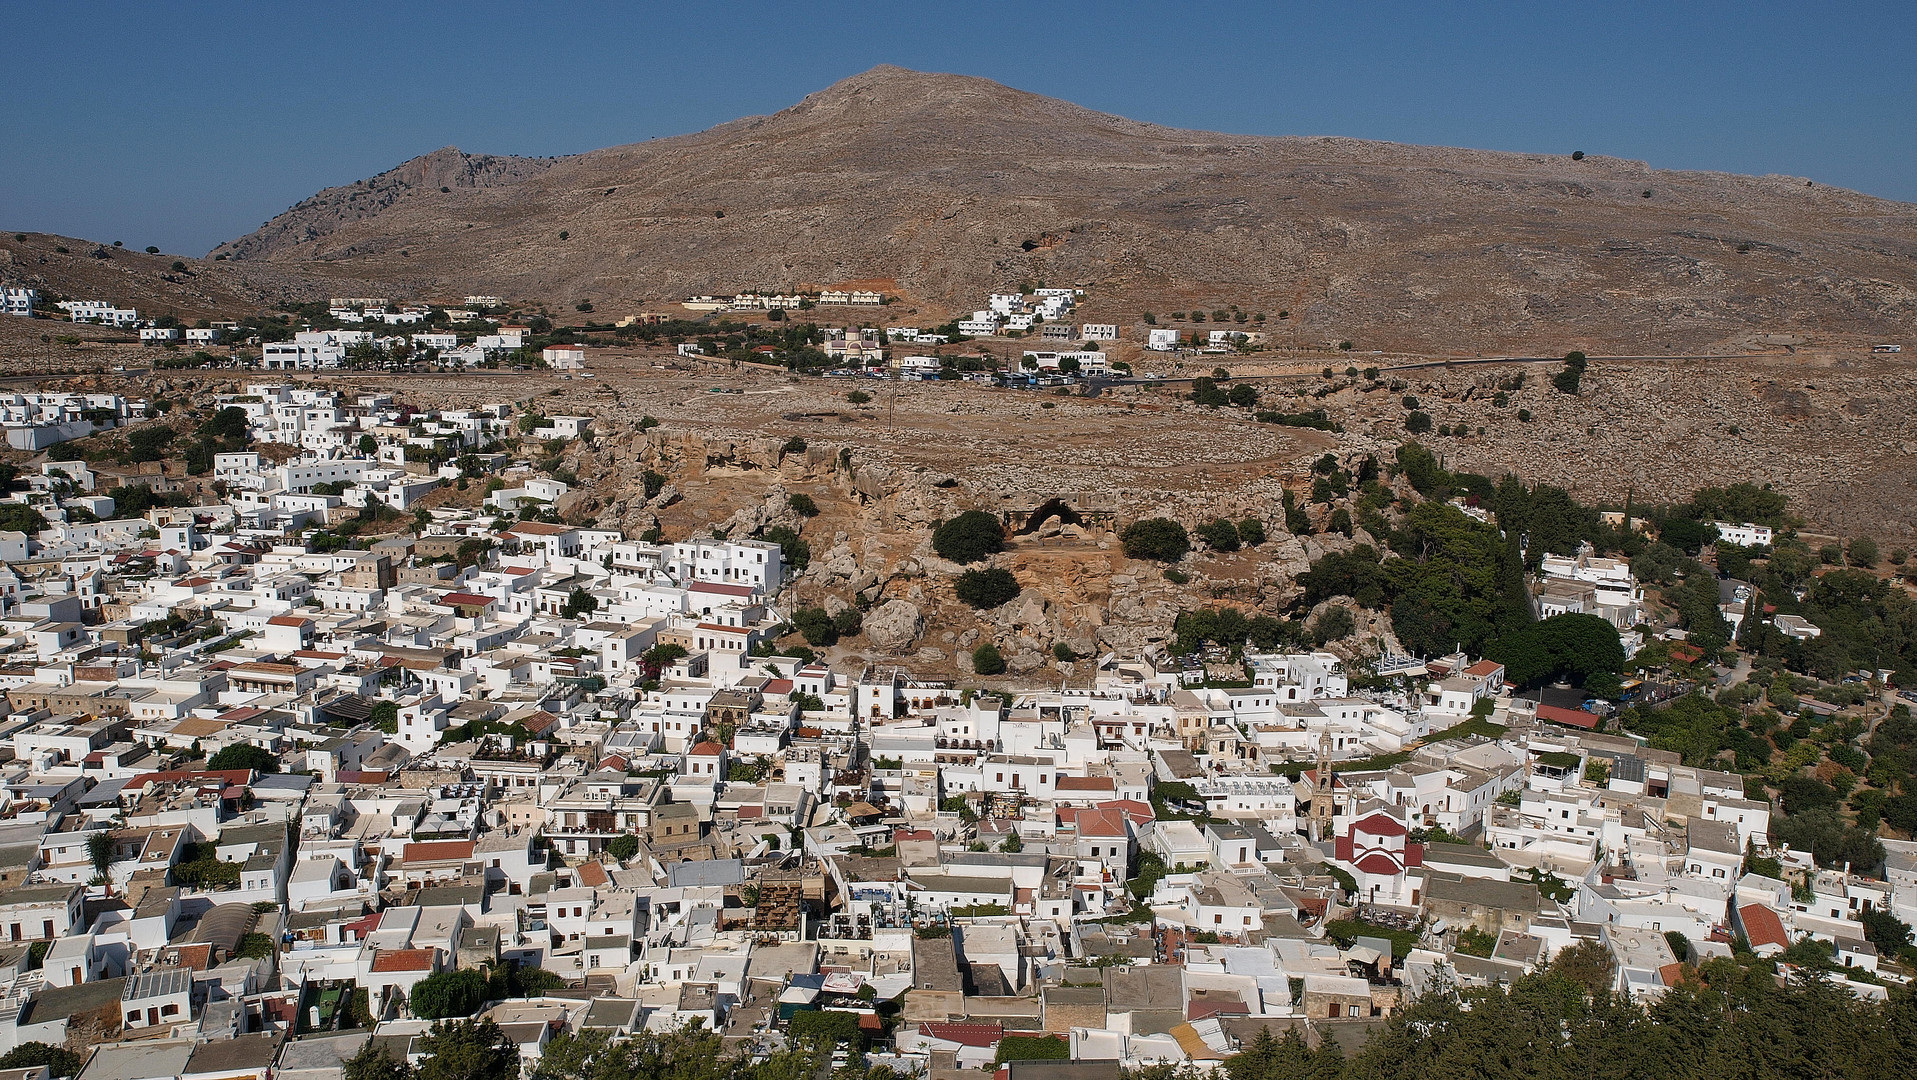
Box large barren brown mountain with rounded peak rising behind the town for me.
[217,67,1917,353]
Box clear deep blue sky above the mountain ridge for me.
[0,0,1917,255]
